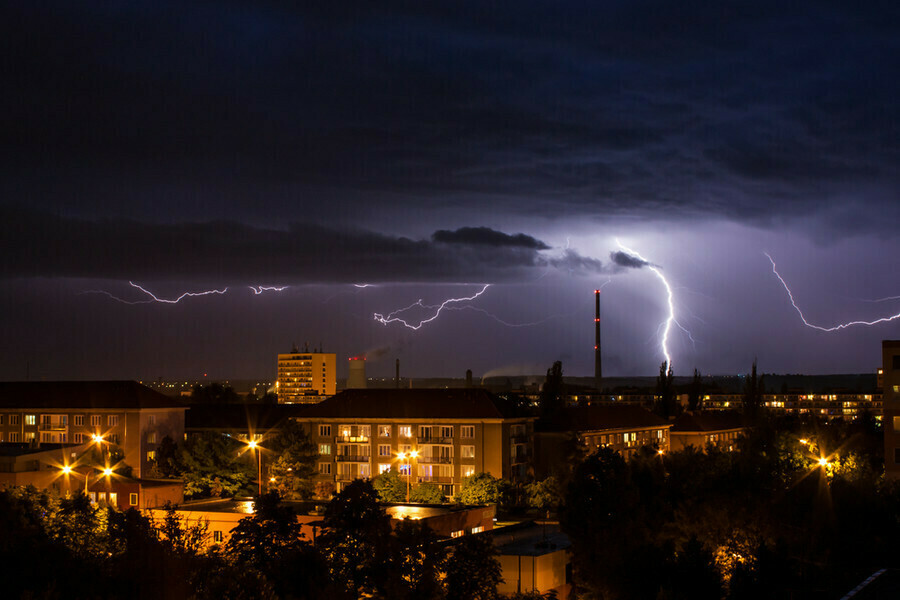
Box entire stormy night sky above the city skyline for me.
[0,0,900,379]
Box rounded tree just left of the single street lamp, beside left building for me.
[180,432,256,496]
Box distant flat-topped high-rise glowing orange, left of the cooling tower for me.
[275,352,337,404]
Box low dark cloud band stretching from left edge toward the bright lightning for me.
[0,207,602,284]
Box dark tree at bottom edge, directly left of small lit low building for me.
[445,534,503,600]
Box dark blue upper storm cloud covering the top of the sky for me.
[0,0,900,228]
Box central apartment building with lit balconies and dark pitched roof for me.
[298,389,534,496]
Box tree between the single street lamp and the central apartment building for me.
[269,419,319,500]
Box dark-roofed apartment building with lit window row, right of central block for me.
[534,405,672,479]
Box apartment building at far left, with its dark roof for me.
[0,381,186,478]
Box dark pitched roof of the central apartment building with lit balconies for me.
[303,388,517,419]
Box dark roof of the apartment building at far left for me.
[0,381,185,409]
